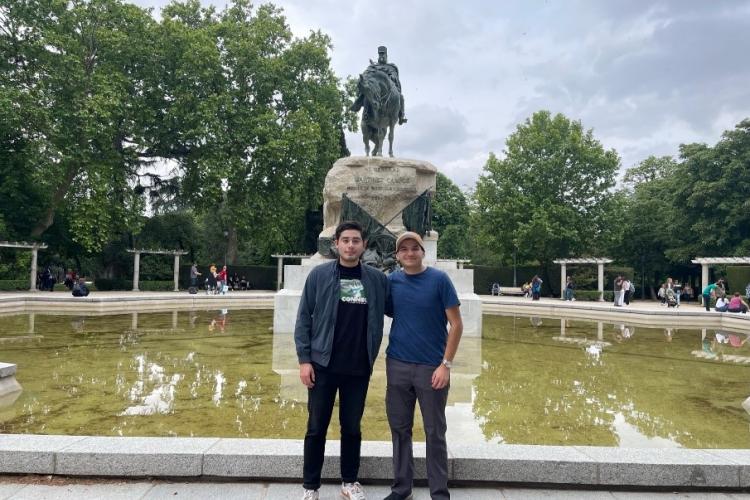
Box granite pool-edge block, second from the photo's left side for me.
[55,436,219,477]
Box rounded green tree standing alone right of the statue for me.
[475,111,620,278]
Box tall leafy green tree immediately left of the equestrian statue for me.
[154,0,344,262]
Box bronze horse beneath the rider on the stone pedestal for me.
[357,68,401,158]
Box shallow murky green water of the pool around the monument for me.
[0,310,750,448]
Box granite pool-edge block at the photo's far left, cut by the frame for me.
[0,434,85,474]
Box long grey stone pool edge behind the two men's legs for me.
[0,434,750,490]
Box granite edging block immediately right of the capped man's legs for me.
[449,445,597,484]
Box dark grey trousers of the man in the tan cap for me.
[385,358,450,500]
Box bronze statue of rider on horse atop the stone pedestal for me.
[351,46,406,157]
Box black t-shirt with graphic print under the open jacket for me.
[327,263,370,375]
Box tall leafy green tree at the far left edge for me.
[0,0,154,250]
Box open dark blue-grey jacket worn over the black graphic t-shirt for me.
[294,260,390,372]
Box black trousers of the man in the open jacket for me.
[302,367,370,490]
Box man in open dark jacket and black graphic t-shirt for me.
[294,222,389,500]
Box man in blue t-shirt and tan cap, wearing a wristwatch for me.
[385,232,463,500]
